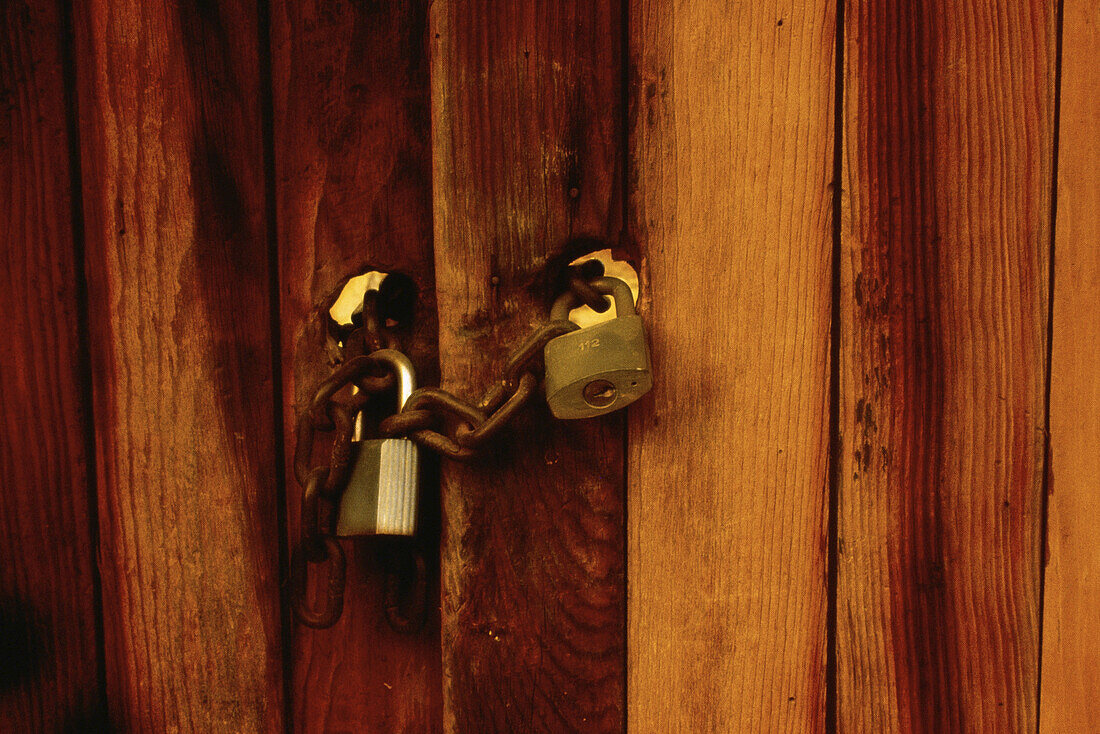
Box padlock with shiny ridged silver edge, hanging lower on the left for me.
[337,349,420,537]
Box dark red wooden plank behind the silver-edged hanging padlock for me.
[272,0,442,734]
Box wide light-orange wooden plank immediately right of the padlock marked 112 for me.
[627,0,836,732]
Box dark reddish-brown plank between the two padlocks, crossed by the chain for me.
[431,0,624,733]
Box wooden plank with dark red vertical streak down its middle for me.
[837,0,1055,732]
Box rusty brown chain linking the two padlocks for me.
[290,267,608,632]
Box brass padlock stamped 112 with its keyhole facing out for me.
[543,277,653,418]
